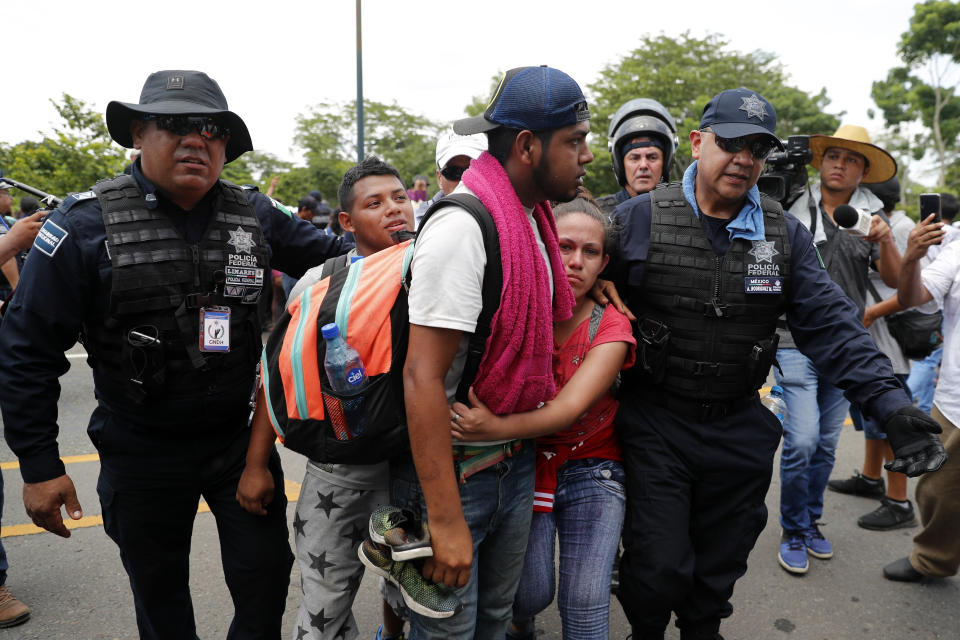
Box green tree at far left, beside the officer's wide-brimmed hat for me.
[0,93,127,198]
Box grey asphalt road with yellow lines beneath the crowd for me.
[0,348,960,640]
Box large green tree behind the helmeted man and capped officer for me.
[585,33,842,196]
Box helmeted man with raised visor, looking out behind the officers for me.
[597,98,678,214]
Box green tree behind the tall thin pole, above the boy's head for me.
[292,100,440,202]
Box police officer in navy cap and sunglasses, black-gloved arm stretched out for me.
[614,88,945,640]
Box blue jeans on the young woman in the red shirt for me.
[513,458,626,640]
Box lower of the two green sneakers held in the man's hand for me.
[357,538,463,618]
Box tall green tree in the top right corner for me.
[871,0,960,188]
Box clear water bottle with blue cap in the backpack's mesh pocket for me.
[320,323,367,440]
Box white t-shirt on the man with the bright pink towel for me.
[408,182,553,445]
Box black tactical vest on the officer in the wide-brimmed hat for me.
[83,176,270,400]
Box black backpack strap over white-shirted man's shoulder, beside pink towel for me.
[418,193,503,404]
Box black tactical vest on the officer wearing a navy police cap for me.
[637,183,791,401]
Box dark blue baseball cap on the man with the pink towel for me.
[453,66,590,136]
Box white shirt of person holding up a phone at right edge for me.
[919,242,960,426]
